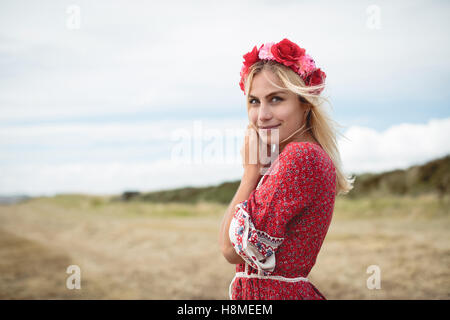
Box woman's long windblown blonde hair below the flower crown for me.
[244,60,356,195]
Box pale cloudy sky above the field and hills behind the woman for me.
[0,0,450,196]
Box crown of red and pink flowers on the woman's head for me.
[239,38,327,94]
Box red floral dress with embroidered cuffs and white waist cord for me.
[229,142,336,300]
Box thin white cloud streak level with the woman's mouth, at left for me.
[0,115,246,150]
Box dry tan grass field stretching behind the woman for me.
[0,195,450,299]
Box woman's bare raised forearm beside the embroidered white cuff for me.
[219,174,258,264]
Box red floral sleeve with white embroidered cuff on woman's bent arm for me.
[229,143,315,275]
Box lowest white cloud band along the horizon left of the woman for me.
[0,160,242,196]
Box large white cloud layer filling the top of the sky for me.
[0,1,450,121]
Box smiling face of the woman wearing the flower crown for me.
[248,69,304,145]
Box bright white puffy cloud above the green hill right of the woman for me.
[339,118,450,173]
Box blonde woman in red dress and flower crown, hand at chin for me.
[219,39,354,300]
